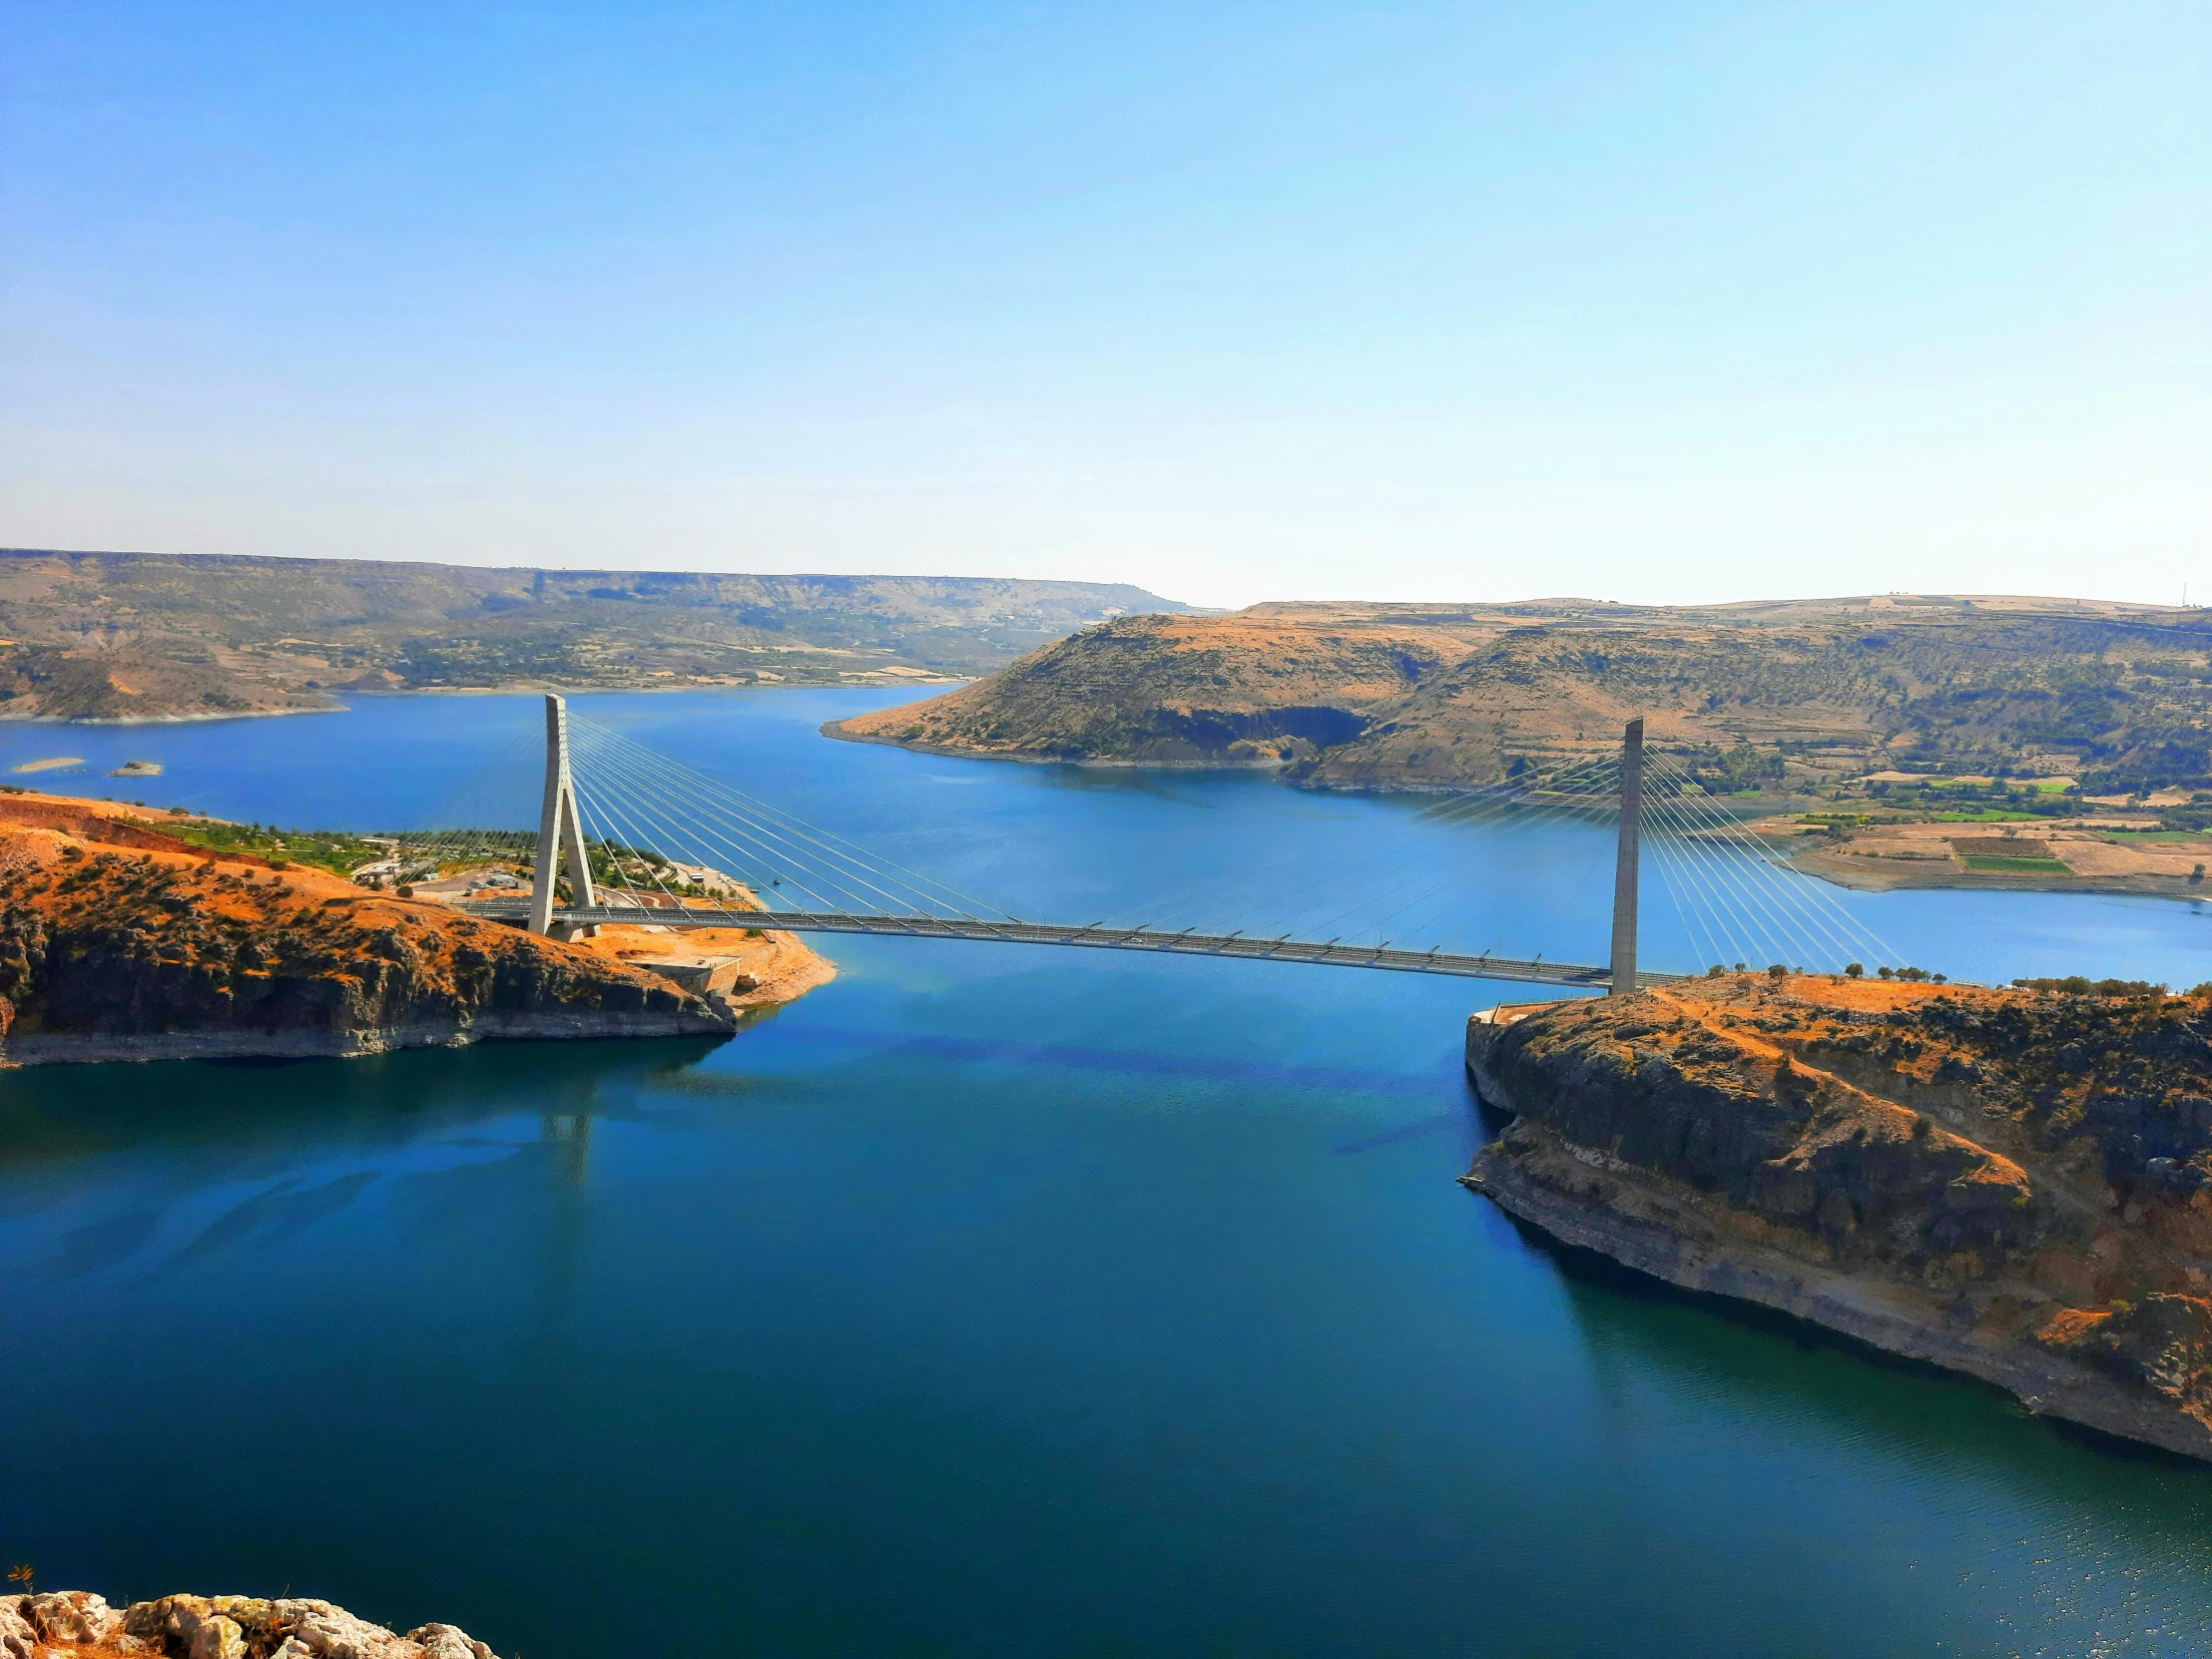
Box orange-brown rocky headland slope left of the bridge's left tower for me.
[0,797,756,1064]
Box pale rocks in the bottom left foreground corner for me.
[0,1590,498,1659]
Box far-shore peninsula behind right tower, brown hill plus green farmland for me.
[823,595,2212,895]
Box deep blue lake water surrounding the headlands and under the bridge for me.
[0,690,2212,1659]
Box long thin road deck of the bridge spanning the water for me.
[460,898,1688,991]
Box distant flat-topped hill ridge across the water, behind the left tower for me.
[0,549,1184,721]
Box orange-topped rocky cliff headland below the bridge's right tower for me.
[1466,975,2212,1457]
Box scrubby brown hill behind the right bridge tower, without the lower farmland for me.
[836,595,2212,790]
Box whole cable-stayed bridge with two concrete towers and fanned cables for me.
[435,697,1887,991]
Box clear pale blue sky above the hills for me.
[0,0,2212,604]
